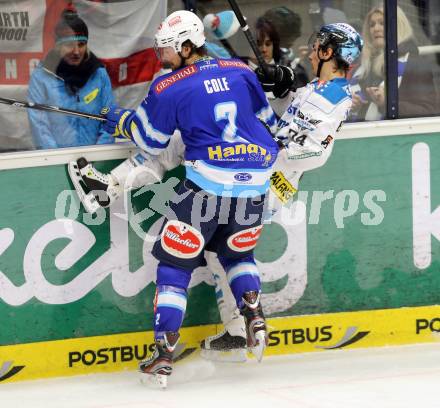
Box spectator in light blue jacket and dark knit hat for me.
[28,10,114,149]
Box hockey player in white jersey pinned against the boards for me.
[70,23,362,361]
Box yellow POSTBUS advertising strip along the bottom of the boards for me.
[0,306,440,382]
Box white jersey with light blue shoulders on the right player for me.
[271,78,352,212]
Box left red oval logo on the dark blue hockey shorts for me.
[161,220,204,259]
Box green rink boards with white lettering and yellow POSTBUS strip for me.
[0,118,440,382]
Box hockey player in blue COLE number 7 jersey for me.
[75,11,278,386]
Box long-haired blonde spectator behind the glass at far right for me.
[351,7,438,120]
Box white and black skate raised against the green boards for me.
[68,157,121,214]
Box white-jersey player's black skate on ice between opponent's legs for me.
[200,315,247,363]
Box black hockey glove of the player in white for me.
[255,65,295,98]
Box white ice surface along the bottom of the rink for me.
[0,343,440,408]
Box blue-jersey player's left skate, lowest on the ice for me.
[139,332,179,389]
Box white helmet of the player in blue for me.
[155,10,206,52]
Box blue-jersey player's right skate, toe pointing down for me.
[240,291,268,362]
